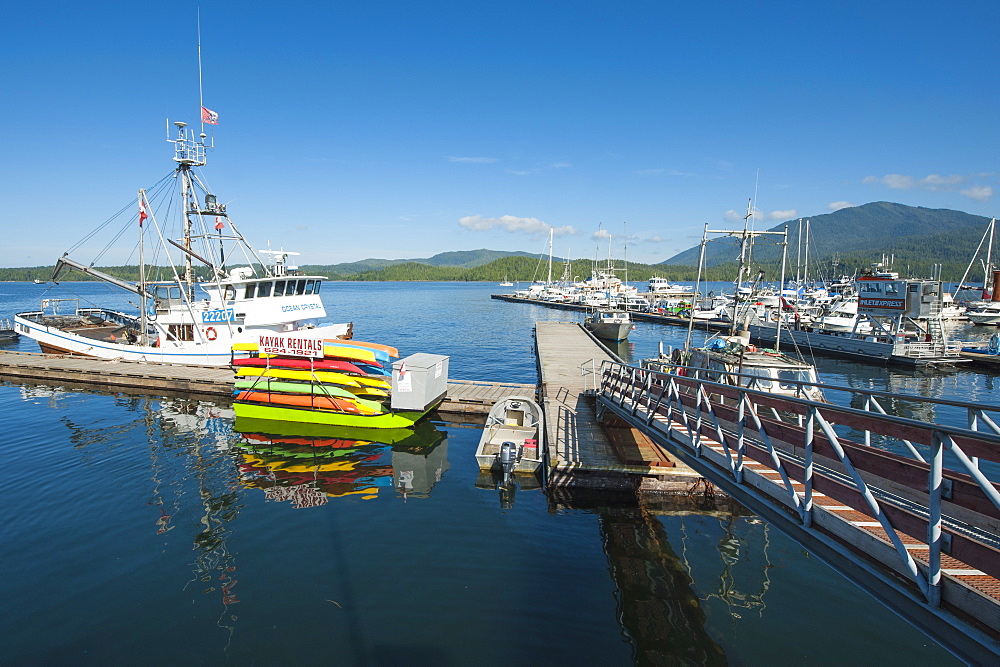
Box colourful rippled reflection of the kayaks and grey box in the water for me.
[235,418,448,509]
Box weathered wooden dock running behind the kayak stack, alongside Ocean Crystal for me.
[0,351,536,415]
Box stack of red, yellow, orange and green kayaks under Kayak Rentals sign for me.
[233,337,419,428]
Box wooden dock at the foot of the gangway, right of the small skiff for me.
[535,322,701,490]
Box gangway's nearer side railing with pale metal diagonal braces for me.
[599,362,1000,620]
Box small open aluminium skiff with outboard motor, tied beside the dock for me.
[476,396,545,476]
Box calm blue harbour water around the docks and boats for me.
[0,283,988,665]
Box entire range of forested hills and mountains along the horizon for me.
[0,202,1000,282]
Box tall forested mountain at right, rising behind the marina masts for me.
[661,202,990,277]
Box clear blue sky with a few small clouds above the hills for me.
[0,0,1000,267]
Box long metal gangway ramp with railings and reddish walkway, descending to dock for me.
[597,362,1000,664]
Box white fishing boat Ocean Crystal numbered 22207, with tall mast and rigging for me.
[14,122,352,366]
